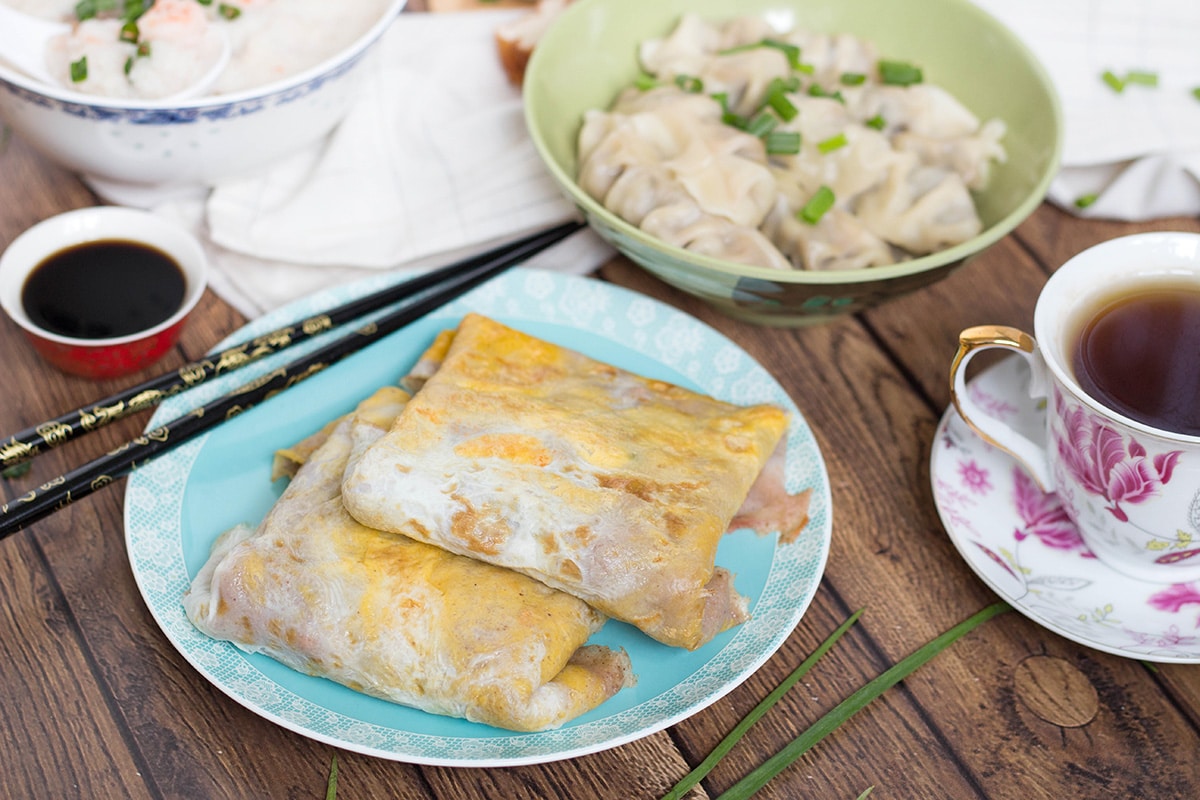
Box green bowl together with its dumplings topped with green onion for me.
[523,0,1063,326]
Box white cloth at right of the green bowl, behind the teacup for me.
[974,0,1200,221]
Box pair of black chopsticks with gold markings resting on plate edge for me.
[0,221,583,539]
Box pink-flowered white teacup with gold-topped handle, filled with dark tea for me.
[950,233,1200,583]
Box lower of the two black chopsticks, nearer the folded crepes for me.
[0,222,583,539]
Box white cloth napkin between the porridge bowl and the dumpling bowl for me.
[157,10,612,317]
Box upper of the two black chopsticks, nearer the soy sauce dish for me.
[0,222,583,469]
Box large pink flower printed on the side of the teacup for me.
[1055,392,1181,522]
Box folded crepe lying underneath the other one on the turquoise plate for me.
[184,387,632,730]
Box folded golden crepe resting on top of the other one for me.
[342,314,808,649]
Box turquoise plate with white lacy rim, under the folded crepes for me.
[125,269,832,766]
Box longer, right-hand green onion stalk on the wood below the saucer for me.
[716,602,1012,800]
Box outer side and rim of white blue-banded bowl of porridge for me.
[0,0,406,205]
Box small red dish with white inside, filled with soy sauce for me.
[0,206,208,379]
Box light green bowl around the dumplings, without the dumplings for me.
[524,0,1062,326]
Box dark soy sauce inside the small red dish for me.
[20,239,187,339]
